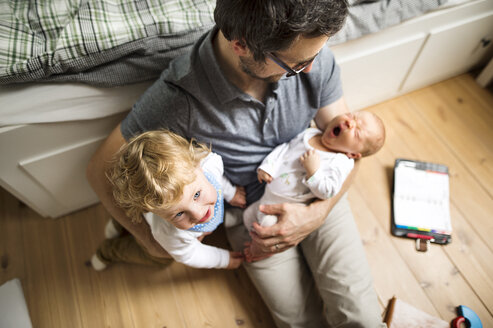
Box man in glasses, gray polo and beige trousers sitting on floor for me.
[88,0,381,328]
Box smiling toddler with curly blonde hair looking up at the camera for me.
[92,130,246,269]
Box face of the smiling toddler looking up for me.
[154,168,217,230]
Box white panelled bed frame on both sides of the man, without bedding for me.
[0,0,493,218]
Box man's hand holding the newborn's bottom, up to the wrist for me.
[250,201,329,254]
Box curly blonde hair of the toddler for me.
[106,130,211,223]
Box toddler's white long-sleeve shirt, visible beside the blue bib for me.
[144,153,236,268]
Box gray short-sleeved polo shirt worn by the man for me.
[121,28,342,203]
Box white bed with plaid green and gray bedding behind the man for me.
[0,0,493,218]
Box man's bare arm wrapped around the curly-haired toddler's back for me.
[86,124,169,257]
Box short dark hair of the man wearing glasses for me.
[214,0,348,61]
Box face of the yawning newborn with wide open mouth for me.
[321,111,379,158]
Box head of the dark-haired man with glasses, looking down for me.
[214,0,348,83]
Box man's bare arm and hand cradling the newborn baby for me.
[251,97,359,253]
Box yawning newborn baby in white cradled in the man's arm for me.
[243,111,385,261]
